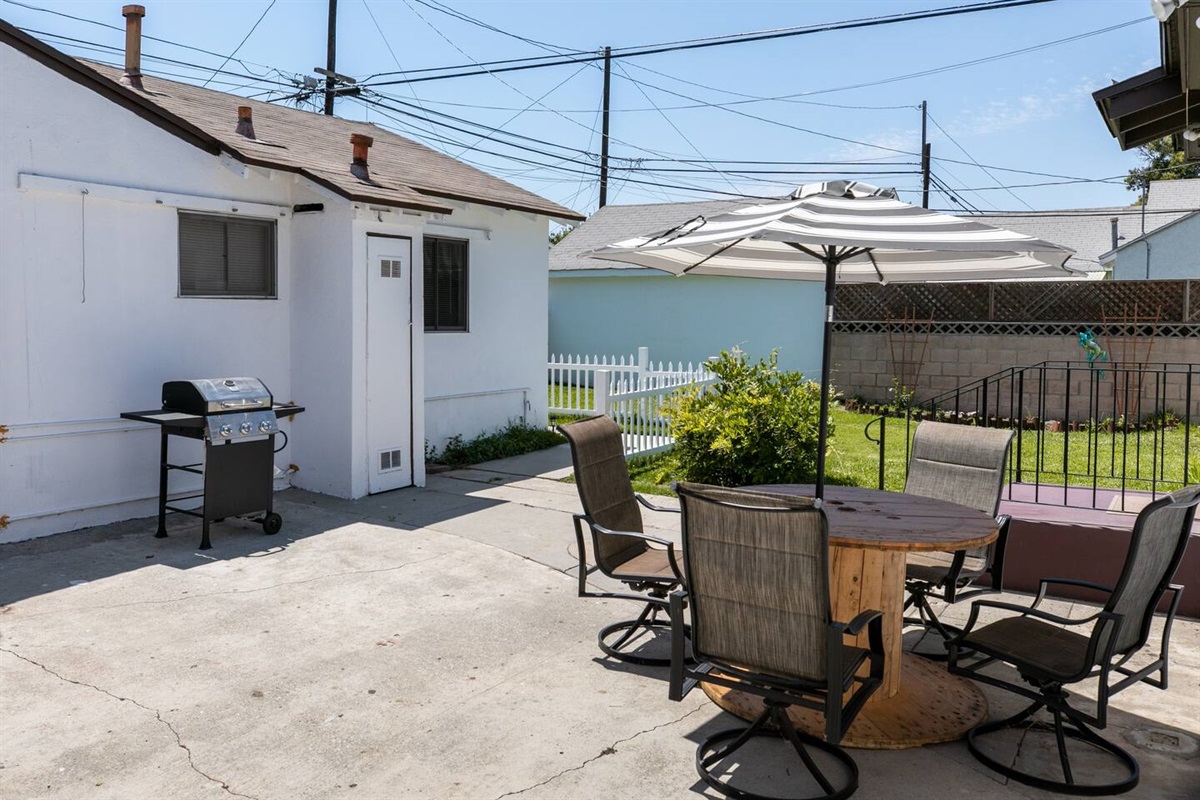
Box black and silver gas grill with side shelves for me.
[121,378,304,551]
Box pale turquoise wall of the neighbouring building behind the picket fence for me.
[550,270,824,379]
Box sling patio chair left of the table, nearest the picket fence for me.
[558,415,682,667]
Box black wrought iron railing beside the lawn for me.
[880,361,1200,511]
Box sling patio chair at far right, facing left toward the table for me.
[949,486,1200,795]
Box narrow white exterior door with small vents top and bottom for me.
[367,235,412,494]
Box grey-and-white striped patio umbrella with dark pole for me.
[587,181,1074,498]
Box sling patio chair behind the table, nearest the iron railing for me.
[904,422,1014,660]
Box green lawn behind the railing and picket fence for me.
[609,408,1200,494]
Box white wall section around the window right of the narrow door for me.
[424,205,550,449]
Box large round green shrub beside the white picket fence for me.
[664,348,833,486]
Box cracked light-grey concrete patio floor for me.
[0,446,1200,800]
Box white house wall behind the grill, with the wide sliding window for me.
[0,47,302,541]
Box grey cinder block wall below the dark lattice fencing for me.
[833,332,1200,420]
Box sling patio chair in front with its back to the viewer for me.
[670,483,883,799]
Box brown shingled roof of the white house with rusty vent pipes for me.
[0,20,583,219]
